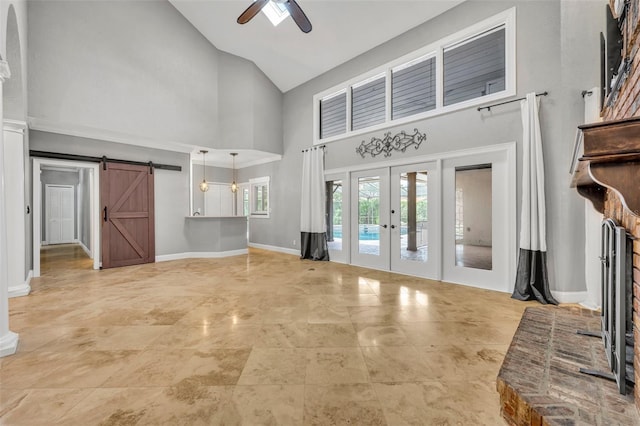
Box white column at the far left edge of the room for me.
[0,60,18,357]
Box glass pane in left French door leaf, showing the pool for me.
[358,176,380,256]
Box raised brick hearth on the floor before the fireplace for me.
[497,307,640,426]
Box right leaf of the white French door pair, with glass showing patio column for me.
[390,162,440,279]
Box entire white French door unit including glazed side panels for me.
[326,143,517,292]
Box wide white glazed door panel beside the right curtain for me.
[442,148,515,292]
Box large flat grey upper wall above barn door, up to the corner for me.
[28,1,218,146]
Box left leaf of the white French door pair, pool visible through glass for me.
[351,168,391,270]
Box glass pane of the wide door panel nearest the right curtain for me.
[455,164,493,270]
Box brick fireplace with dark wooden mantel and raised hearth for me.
[498,0,640,425]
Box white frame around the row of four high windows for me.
[313,7,516,145]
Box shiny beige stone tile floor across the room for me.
[0,245,528,426]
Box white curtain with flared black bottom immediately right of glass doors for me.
[511,93,558,305]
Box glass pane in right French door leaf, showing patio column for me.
[396,171,429,262]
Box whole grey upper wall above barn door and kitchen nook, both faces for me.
[29,0,282,153]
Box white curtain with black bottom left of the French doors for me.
[300,148,329,260]
